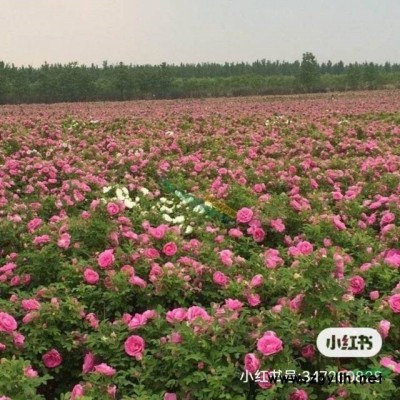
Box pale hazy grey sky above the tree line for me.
[0,0,400,66]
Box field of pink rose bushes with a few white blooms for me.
[0,92,400,400]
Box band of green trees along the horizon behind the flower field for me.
[0,53,400,104]
